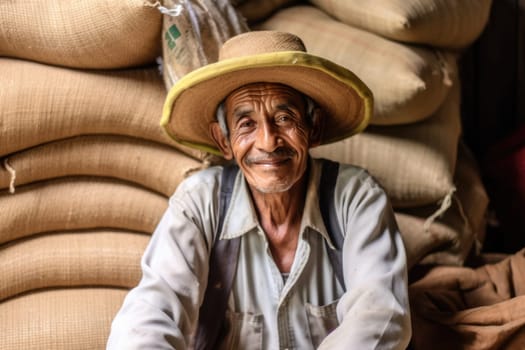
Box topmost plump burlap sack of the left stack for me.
[0,0,162,69]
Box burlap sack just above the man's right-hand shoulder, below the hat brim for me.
[310,77,461,208]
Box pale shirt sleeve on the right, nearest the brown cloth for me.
[319,170,411,350]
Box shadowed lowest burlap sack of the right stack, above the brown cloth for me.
[396,143,489,267]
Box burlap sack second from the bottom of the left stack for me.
[0,230,149,301]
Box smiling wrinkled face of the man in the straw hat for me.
[211,83,320,193]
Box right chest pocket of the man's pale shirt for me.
[305,300,339,348]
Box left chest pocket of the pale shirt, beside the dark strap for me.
[219,310,264,350]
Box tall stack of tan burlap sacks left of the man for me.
[0,0,223,350]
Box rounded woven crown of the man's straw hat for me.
[219,31,306,61]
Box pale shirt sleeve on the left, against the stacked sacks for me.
[107,169,216,350]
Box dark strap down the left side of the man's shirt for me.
[195,165,240,350]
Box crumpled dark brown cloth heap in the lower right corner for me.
[409,249,525,350]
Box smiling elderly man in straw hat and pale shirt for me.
[108,31,411,350]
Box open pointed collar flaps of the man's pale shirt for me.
[220,158,334,248]
